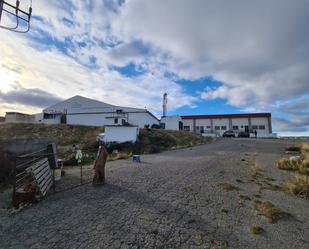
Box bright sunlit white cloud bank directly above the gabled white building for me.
[0,21,195,114]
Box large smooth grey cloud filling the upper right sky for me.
[112,0,309,133]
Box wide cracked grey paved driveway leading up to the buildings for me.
[0,139,309,249]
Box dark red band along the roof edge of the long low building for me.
[181,112,271,119]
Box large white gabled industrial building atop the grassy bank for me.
[36,96,159,128]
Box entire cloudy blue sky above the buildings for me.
[0,0,309,136]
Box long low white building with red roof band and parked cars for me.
[161,113,272,137]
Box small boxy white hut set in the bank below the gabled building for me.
[104,125,139,143]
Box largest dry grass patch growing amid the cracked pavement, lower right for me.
[254,200,287,223]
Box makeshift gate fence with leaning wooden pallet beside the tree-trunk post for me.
[12,144,96,207]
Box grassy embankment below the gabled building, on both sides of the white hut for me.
[0,123,210,159]
